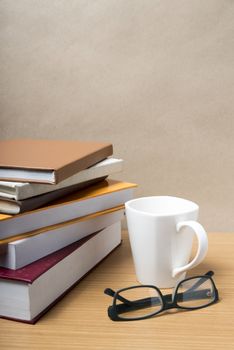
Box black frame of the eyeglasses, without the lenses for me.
[104,271,219,321]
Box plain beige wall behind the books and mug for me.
[0,0,234,231]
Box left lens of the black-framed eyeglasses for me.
[116,287,163,319]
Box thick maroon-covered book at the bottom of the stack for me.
[0,223,121,323]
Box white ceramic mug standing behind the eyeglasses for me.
[125,196,208,288]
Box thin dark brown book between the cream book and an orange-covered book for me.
[0,177,106,215]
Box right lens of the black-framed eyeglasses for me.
[176,276,215,309]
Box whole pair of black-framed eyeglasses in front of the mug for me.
[104,271,219,321]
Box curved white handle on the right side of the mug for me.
[172,221,208,277]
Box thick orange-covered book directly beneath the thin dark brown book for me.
[0,180,136,244]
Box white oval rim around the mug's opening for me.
[125,195,199,217]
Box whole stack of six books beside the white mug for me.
[0,140,136,323]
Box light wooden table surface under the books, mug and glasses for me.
[0,232,234,350]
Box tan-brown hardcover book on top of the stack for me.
[0,139,113,184]
